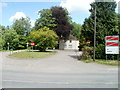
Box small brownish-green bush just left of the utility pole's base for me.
[80,46,93,60]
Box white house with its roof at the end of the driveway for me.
[59,36,79,50]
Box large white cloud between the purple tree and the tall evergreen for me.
[60,0,120,13]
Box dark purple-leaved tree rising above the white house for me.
[51,6,72,40]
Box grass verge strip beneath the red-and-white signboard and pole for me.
[81,59,120,66]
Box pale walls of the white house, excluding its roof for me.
[59,40,79,50]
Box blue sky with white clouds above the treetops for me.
[0,0,119,26]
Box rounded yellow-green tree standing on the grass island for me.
[29,27,58,51]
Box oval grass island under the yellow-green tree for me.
[9,51,57,59]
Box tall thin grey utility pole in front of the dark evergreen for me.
[93,2,96,61]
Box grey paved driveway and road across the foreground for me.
[0,51,118,88]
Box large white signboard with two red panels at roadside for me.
[105,36,119,54]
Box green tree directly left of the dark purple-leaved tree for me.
[34,9,56,30]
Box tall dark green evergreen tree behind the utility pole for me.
[82,2,118,44]
